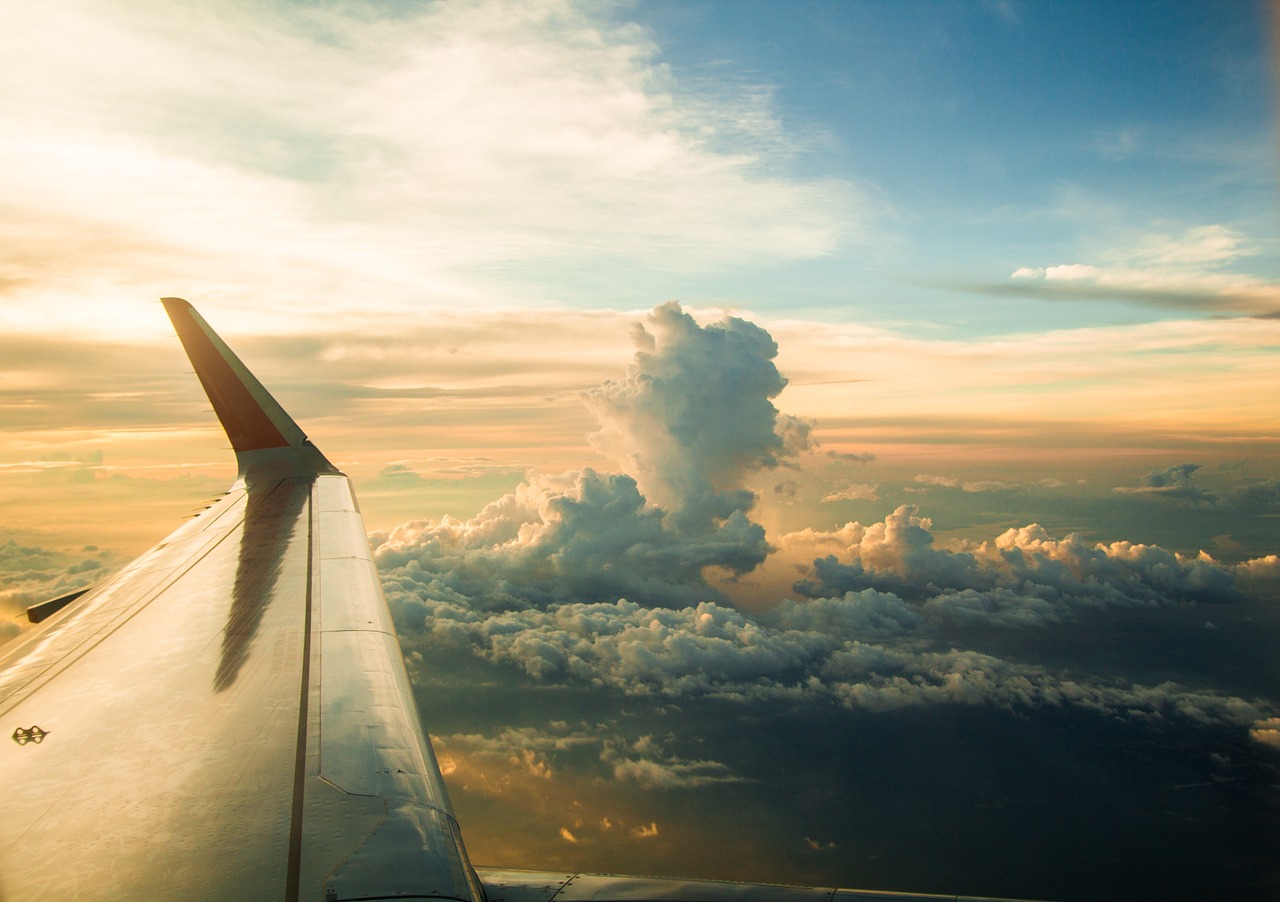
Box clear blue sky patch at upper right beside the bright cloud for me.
[606,3,1276,335]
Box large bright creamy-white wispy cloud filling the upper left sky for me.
[0,0,869,328]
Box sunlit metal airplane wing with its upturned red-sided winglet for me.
[0,298,1039,902]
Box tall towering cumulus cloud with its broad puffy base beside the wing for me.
[374,303,809,619]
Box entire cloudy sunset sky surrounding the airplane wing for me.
[0,0,1280,898]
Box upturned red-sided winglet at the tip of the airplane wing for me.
[160,298,337,477]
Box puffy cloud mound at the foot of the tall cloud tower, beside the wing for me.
[372,470,768,610]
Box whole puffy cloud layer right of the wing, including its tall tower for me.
[374,305,1280,747]
